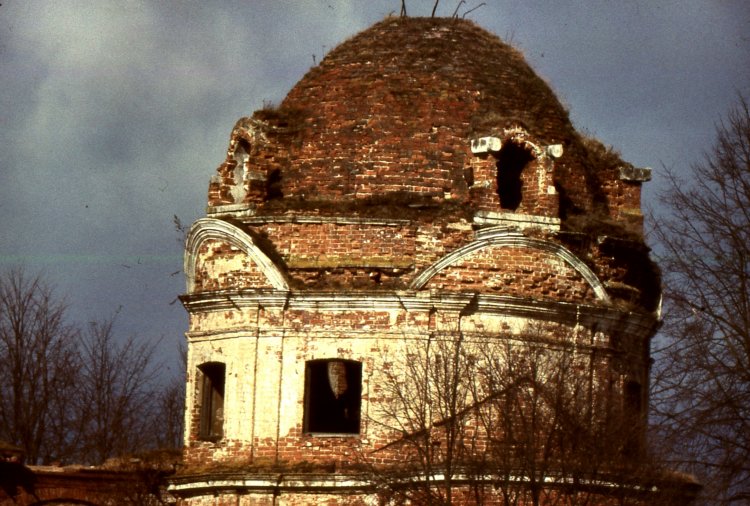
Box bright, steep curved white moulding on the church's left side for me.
[184,218,289,293]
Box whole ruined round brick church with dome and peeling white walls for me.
[170,17,692,505]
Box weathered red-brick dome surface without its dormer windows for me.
[274,18,573,203]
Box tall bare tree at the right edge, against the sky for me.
[653,98,750,504]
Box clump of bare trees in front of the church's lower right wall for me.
[370,326,657,505]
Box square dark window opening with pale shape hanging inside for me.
[303,359,362,434]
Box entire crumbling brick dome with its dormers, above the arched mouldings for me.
[203,18,659,306]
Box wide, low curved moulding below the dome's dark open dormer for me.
[410,227,610,303]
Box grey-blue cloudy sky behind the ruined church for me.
[0,0,750,380]
